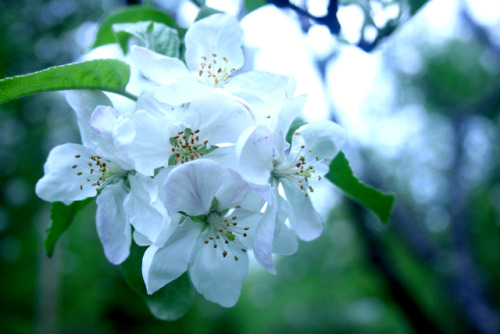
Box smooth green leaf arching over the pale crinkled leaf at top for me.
[91,6,175,48]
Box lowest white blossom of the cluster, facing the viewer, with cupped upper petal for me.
[143,160,263,307]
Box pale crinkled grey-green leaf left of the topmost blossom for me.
[112,21,180,58]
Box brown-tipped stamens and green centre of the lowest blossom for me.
[204,205,250,261]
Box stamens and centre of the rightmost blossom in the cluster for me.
[271,145,327,197]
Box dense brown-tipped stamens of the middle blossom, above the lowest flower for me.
[172,129,208,165]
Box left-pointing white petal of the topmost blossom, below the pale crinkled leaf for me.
[130,45,189,84]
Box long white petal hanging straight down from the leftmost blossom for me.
[96,180,132,264]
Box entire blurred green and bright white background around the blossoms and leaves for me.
[0,0,500,333]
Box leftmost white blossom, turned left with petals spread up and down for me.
[36,91,166,264]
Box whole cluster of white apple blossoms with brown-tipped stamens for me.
[36,14,345,307]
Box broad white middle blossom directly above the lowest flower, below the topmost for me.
[114,92,254,176]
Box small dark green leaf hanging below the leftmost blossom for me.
[43,197,94,257]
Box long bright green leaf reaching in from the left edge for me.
[0,59,137,104]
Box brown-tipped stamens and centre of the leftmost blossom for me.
[72,154,128,192]
